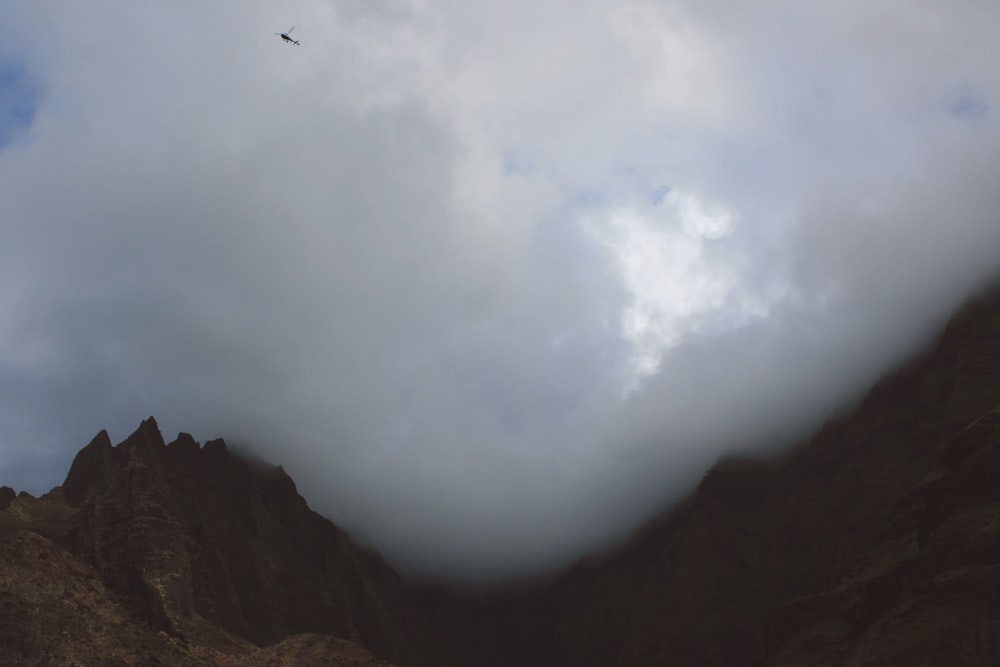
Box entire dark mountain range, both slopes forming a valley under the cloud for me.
[0,284,1000,667]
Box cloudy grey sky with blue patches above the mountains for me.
[0,0,1000,578]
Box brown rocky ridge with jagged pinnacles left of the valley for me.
[0,418,448,665]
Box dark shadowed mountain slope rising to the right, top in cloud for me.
[429,284,1000,667]
